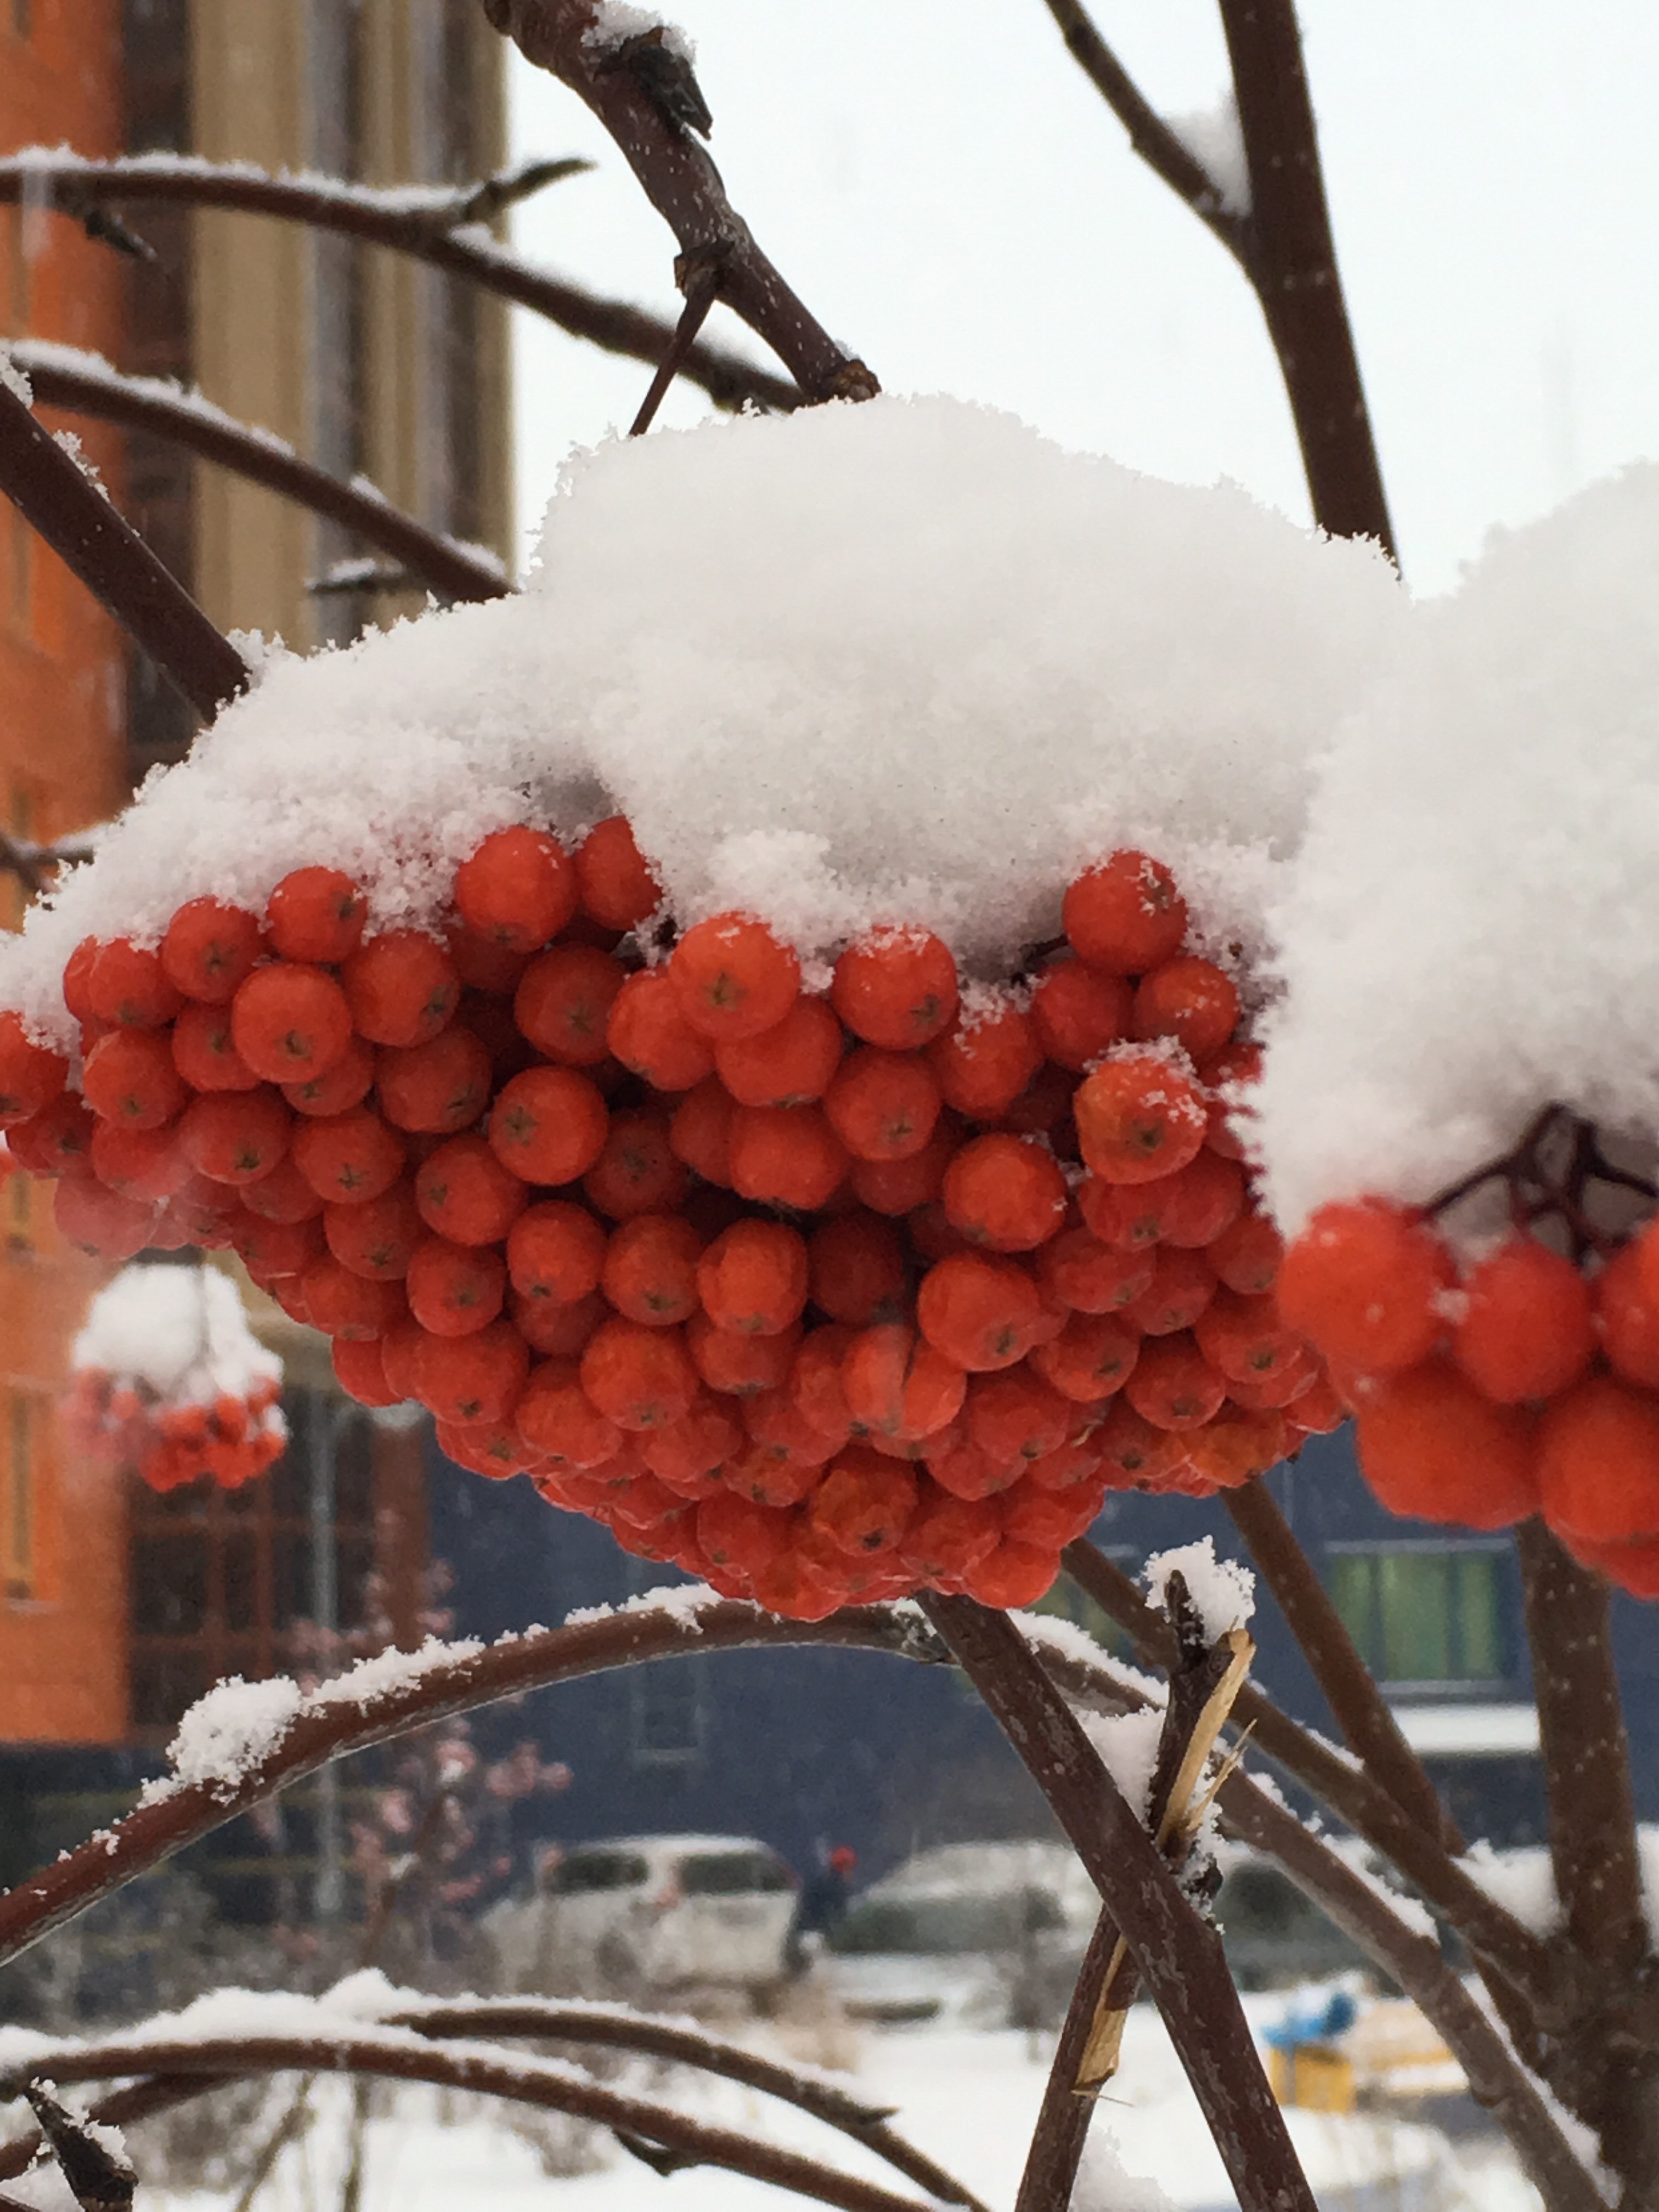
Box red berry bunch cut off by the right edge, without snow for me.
[1278,1199,1659,1597]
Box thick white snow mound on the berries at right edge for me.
[1254,465,1659,1232]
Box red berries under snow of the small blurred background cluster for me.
[64,1367,287,1491]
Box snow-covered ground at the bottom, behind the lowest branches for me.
[55,2000,1537,2212]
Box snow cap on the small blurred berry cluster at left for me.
[69,1265,283,1404]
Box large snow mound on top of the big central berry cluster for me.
[0,398,1407,1042]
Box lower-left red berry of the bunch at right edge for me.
[1358,1361,1548,1528]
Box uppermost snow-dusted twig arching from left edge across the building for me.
[0,153,801,414]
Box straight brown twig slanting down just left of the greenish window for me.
[1221,1482,1464,1856]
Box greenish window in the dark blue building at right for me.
[1329,1544,1509,1683]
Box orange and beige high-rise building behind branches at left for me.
[0,0,511,1796]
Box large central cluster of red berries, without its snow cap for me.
[0,816,1340,1617]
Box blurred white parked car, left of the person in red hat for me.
[484,1836,799,1995]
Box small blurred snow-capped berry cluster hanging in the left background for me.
[64,1265,287,1491]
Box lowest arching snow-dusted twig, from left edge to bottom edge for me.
[0,2024,924,2212]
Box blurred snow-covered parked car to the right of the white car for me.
[825,1843,1099,2026]
